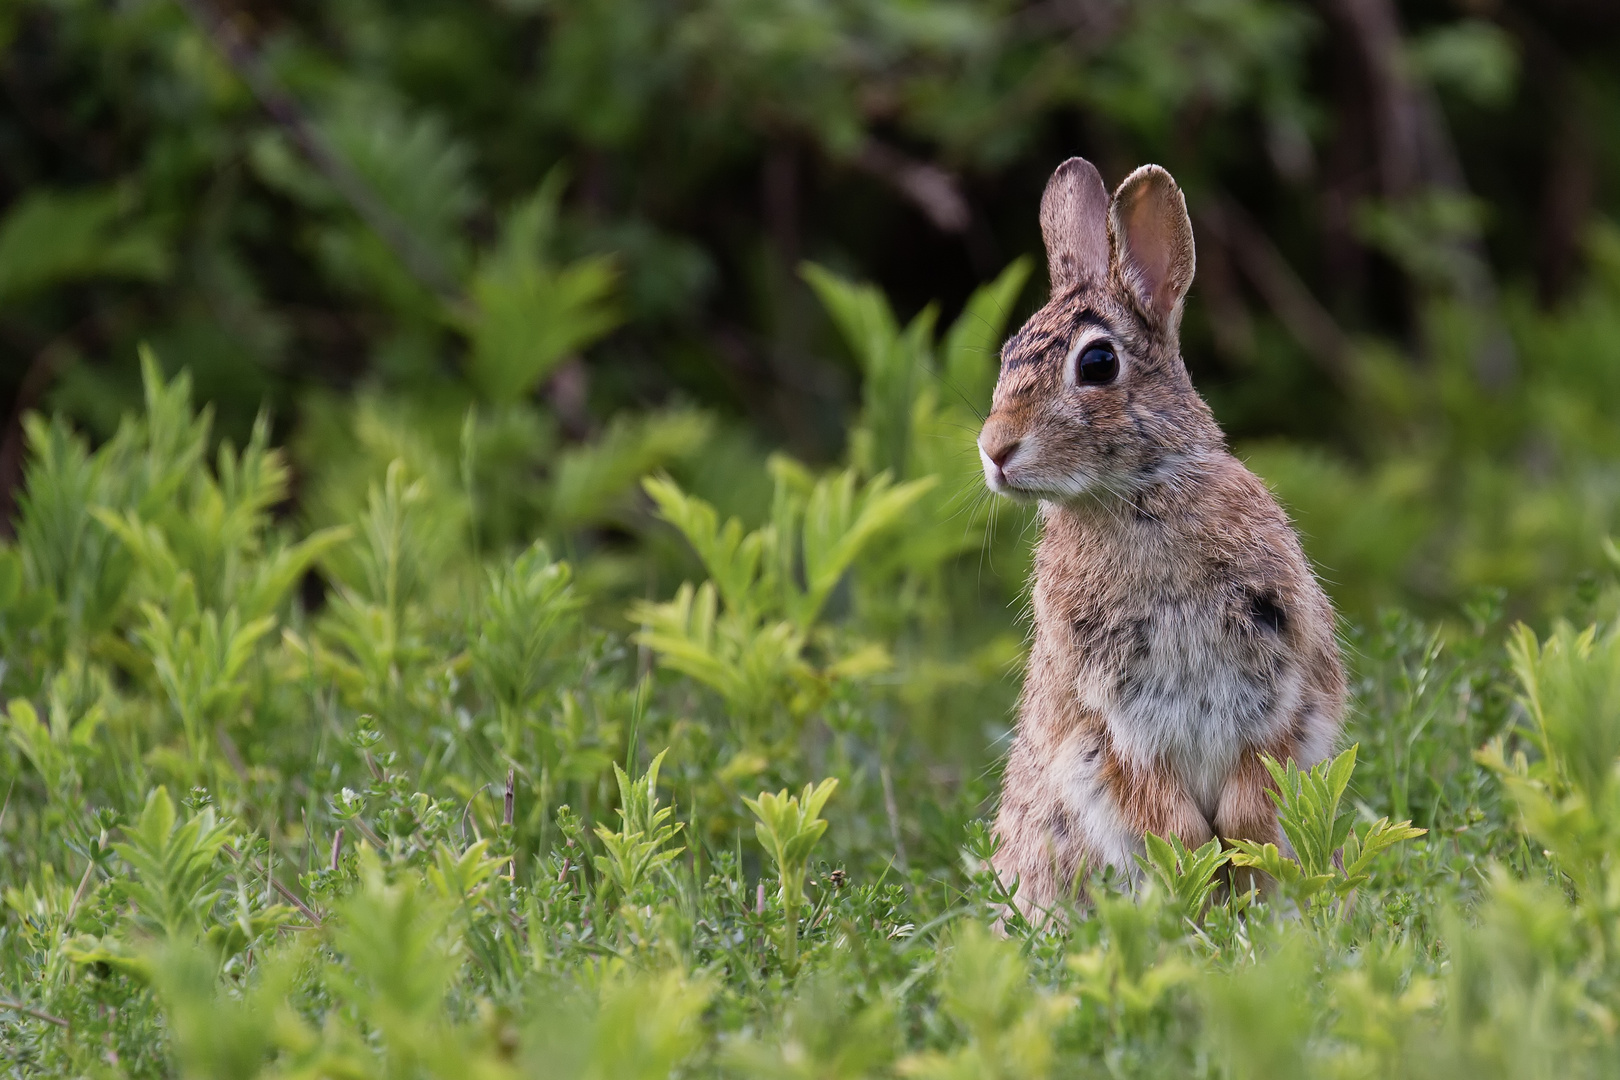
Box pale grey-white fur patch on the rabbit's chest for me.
[1072,591,1299,813]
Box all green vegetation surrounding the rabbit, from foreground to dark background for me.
[9,0,1620,1080]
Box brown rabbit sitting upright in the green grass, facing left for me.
[978,157,1345,918]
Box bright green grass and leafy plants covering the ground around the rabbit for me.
[0,331,1620,1080]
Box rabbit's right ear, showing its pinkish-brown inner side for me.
[1108,165,1194,332]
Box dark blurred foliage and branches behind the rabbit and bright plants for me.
[0,0,1620,615]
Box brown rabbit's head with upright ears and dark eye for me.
[978,157,1221,502]
